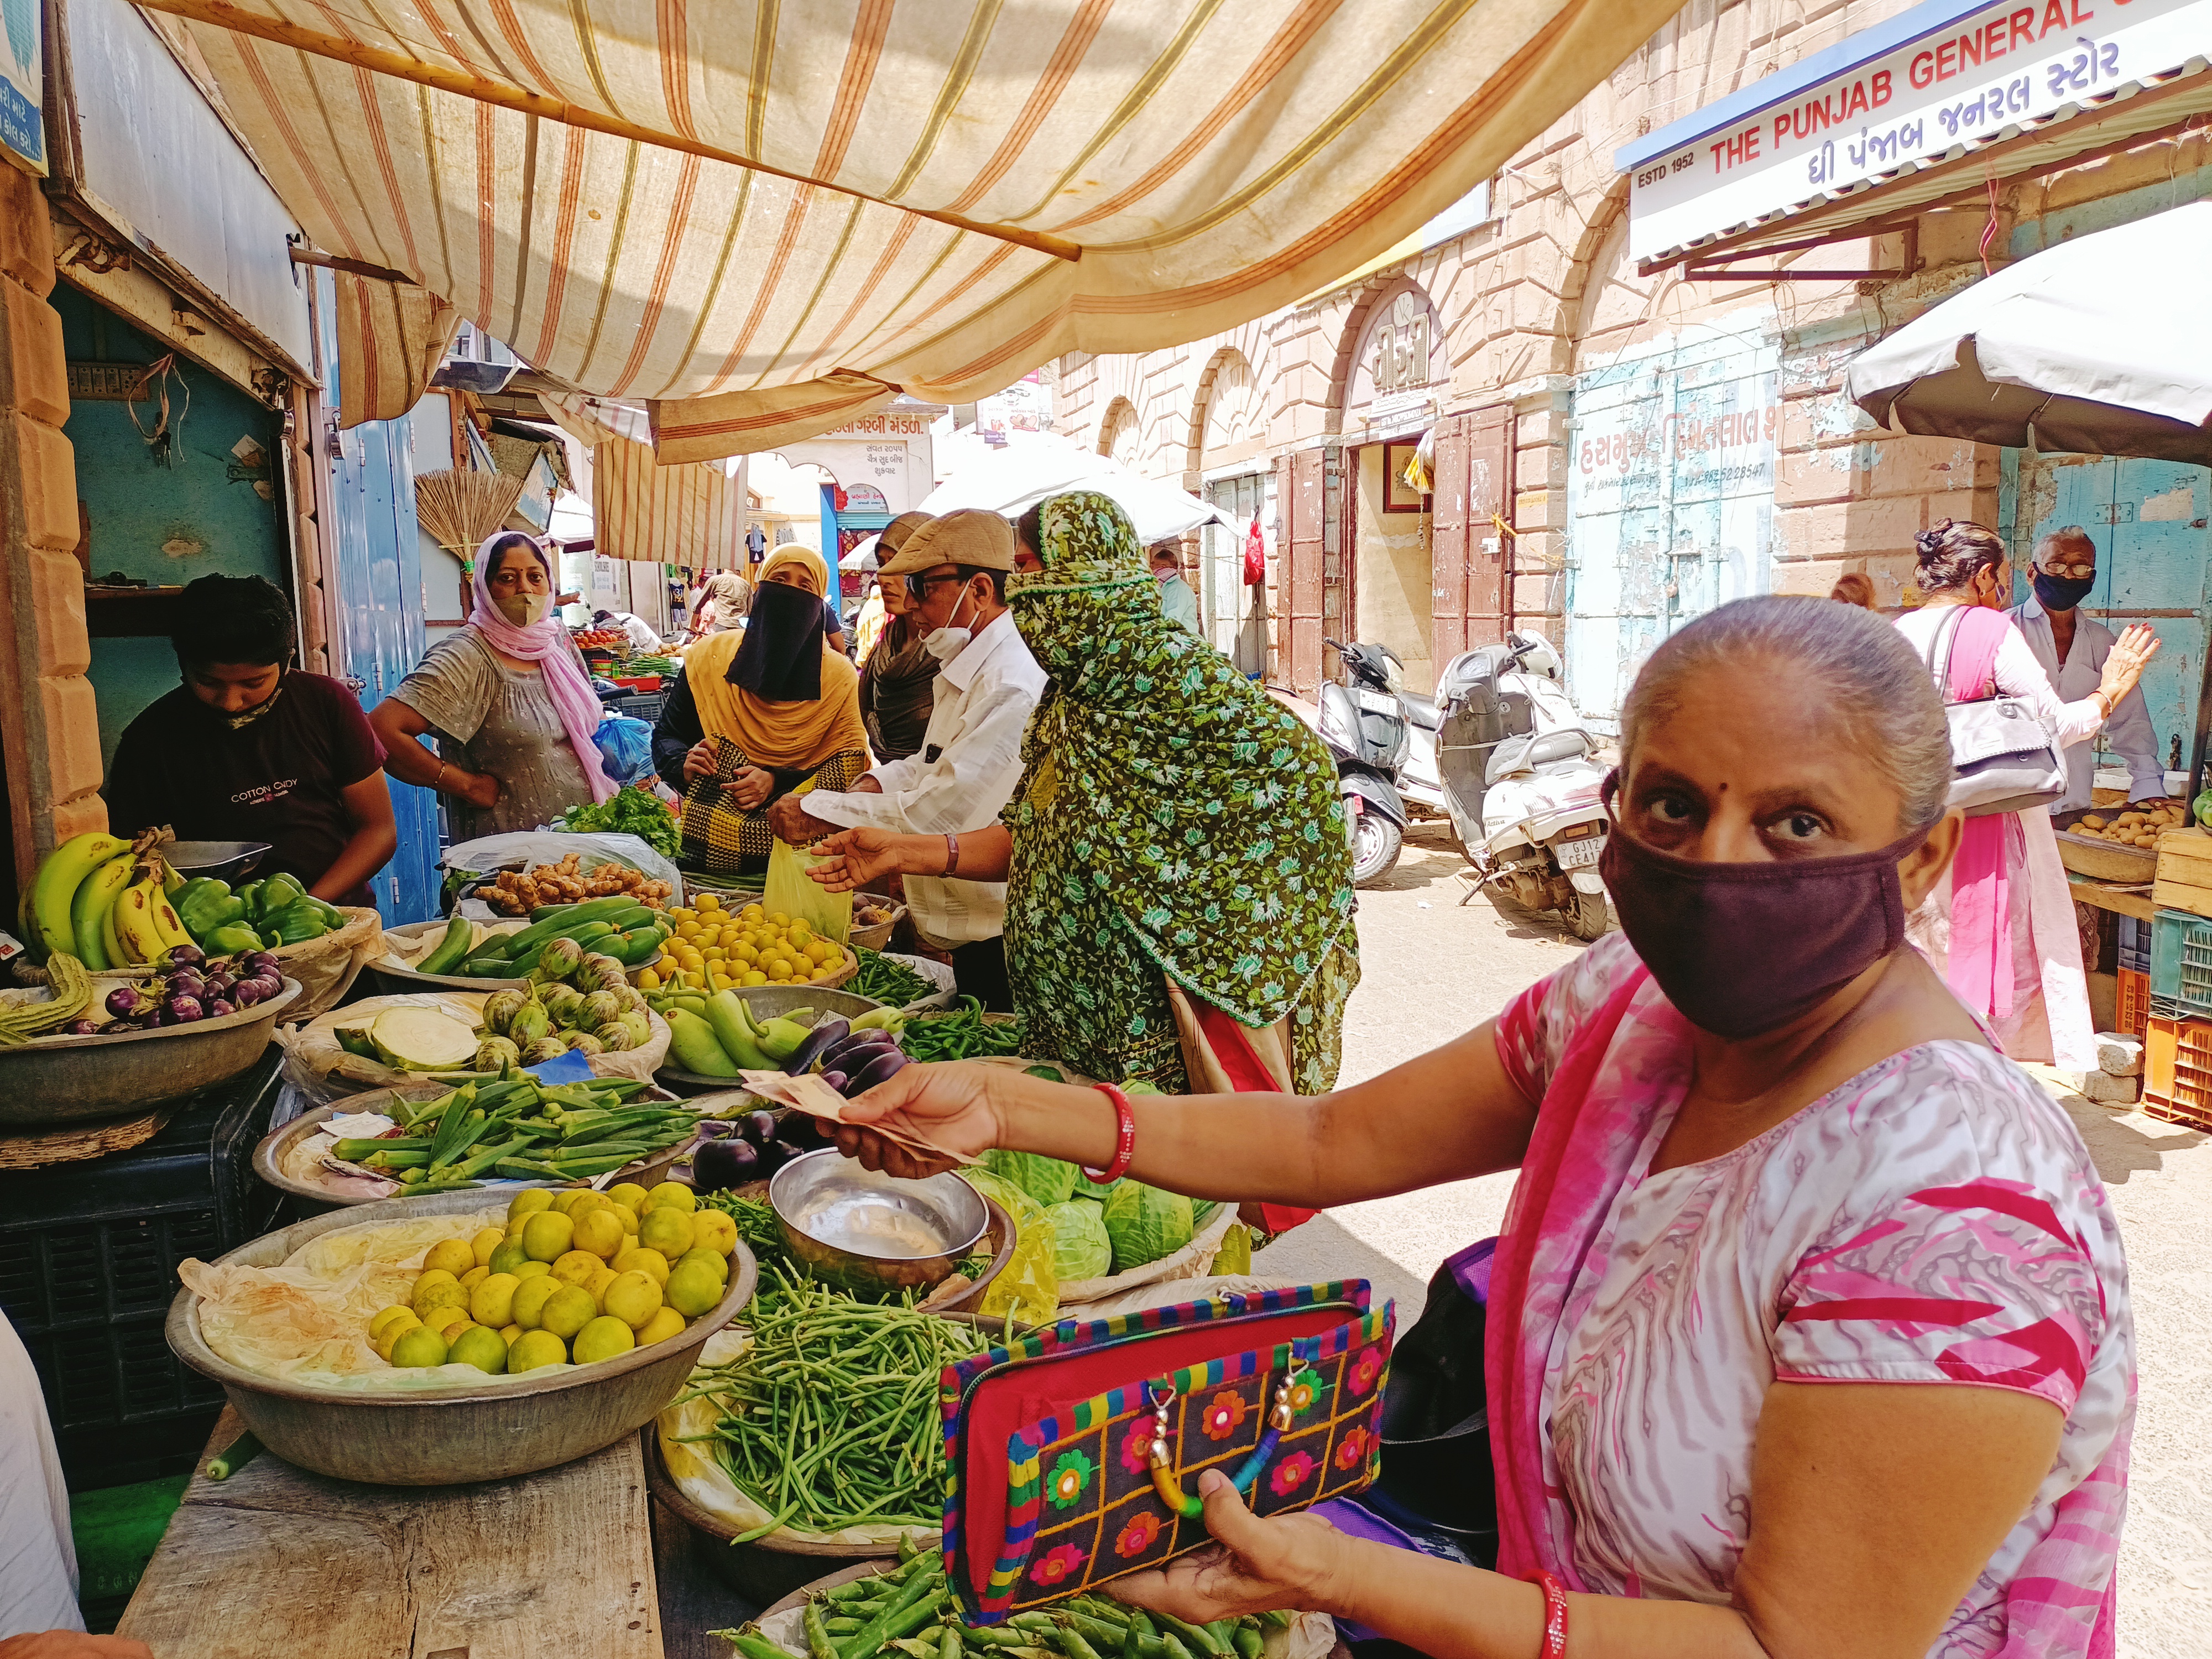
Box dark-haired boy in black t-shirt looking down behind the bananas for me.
[106,575,398,905]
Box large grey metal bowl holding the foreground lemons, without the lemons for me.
[166,1192,759,1486]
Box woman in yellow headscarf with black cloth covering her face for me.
[653,546,869,876]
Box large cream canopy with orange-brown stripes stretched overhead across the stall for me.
[138,0,1681,460]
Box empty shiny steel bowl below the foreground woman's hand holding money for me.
[768,1146,991,1294]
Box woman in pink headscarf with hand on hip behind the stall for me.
[369,531,615,841]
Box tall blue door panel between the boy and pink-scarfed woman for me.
[316,272,438,927]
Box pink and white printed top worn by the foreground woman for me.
[1498,933,2135,1659]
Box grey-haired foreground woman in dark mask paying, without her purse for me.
[838,599,2135,1659]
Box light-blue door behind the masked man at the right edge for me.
[2015,456,2212,792]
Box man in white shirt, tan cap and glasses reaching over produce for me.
[768,511,1046,1013]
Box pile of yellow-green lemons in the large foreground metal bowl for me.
[369,1181,737,1376]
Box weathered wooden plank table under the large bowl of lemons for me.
[117,1409,754,1659]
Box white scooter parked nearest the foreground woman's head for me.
[1438,633,1608,940]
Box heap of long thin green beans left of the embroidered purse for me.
[679,1261,984,1544]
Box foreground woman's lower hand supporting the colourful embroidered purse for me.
[1106,1469,1349,1624]
